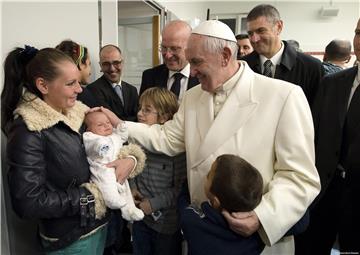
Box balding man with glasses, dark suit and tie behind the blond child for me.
[140,20,199,100]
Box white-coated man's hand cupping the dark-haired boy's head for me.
[222,210,260,237]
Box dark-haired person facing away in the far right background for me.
[323,39,351,74]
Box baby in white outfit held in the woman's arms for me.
[83,112,144,221]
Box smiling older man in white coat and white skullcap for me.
[114,20,320,254]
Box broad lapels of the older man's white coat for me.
[192,63,258,167]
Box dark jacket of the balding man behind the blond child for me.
[139,64,199,95]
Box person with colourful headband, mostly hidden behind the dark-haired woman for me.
[55,40,99,107]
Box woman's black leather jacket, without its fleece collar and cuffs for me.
[7,99,107,249]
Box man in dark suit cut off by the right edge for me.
[296,19,360,255]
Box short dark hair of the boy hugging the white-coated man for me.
[210,154,263,213]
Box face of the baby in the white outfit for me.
[87,112,113,136]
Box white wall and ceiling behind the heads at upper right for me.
[159,0,360,51]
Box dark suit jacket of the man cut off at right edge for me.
[313,67,360,198]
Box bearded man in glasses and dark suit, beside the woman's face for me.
[88,45,138,121]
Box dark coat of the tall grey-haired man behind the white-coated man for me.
[243,41,324,106]
